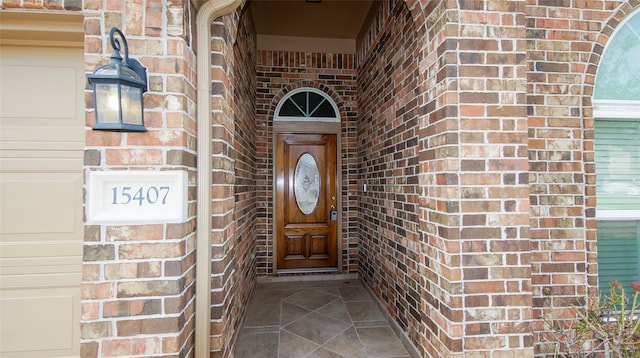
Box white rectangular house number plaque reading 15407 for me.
[87,171,187,224]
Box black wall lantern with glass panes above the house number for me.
[87,27,147,132]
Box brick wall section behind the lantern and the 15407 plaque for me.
[81,0,196,357]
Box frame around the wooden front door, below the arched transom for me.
[271,120,343,275]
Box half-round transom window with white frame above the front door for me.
[274,87,340,122]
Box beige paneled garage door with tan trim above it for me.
[0,13,85,358]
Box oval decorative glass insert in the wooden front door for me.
[293,153,320,215]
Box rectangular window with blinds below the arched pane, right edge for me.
[595,119,640,292]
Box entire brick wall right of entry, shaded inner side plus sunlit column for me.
[359,1,533,357]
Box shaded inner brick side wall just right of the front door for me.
[357,2,424,348]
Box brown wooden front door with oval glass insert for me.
[275,134,339,270]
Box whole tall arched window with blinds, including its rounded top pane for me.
[593,10,640,298]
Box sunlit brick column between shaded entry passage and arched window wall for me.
[420,1,533,357]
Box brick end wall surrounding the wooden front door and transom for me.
[256,50,358,275]
